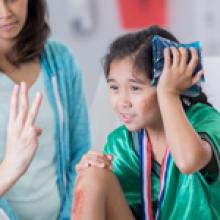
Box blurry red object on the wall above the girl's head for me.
[118,0,166,29]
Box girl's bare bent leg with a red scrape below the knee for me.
[72,167,135,220]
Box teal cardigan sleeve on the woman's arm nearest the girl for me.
[58,44,91,219]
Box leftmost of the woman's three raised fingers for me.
[9,85,19,124]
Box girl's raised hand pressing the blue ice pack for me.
[157,47,204,96]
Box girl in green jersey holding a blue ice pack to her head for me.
[72,26,220,220]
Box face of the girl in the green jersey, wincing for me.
[107,57,160,131]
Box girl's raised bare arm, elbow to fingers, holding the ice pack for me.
[157,48,212,174]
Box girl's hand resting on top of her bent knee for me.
[76,150,113,173]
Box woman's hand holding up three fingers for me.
[2,82,42,178]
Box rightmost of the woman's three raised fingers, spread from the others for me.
[26,92,42,126]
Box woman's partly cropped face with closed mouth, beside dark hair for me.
[0,0,28,43]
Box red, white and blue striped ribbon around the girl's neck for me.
[140,129,170,220]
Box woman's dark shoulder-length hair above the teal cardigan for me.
[7,0,50,65]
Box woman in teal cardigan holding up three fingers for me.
[0,0,90,220]
